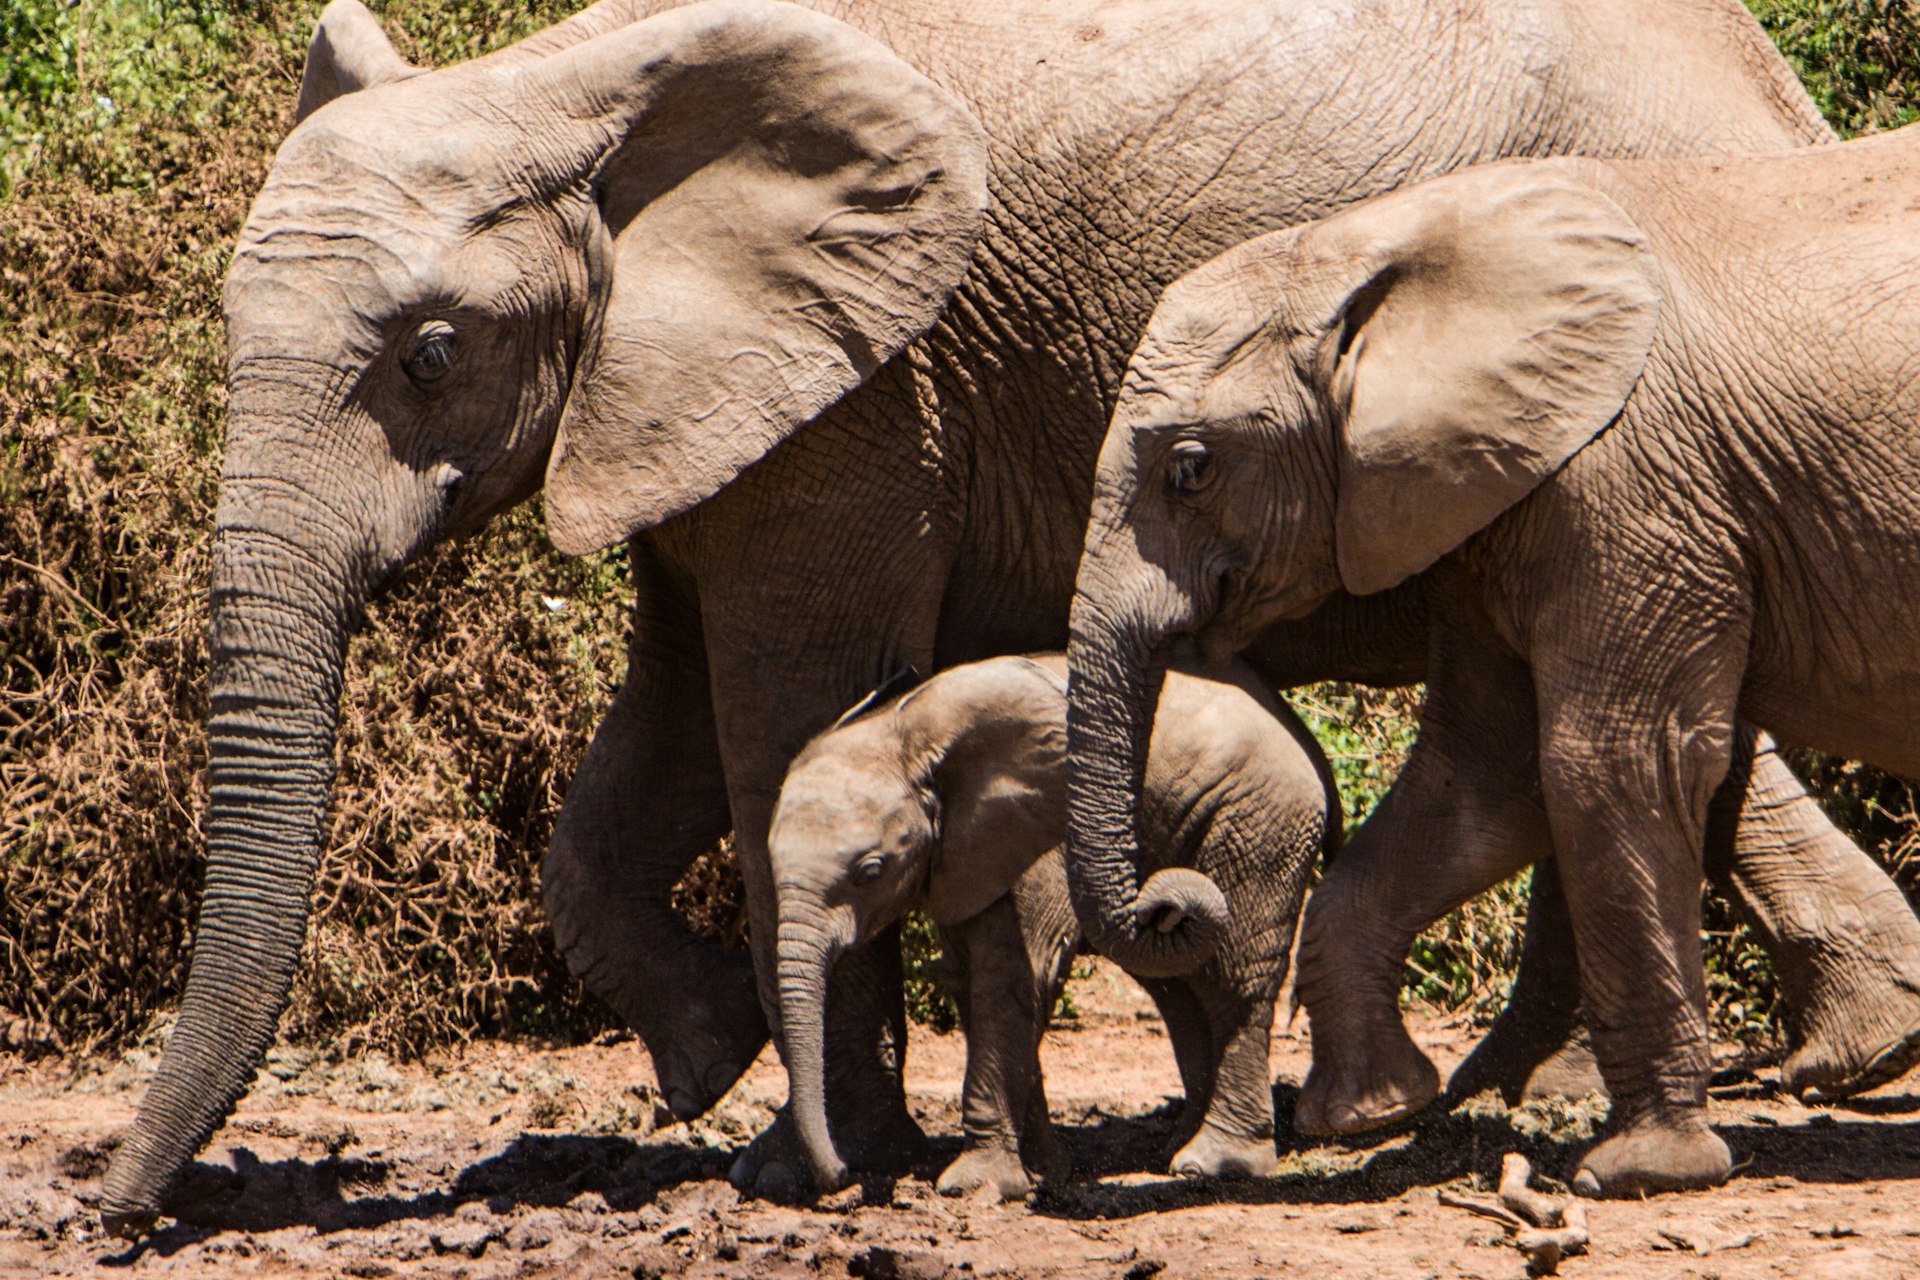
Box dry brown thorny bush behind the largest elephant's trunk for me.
[0,5,645,1050]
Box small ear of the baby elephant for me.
[900,658,1068,925]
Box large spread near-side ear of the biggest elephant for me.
[533,0,987,553]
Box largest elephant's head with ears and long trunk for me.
[102,0,985,1232]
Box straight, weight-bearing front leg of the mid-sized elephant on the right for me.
[1536,625,1745,1196]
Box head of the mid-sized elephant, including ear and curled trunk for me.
[1068,163,1661,969]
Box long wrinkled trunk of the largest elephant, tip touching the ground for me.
[100,382,405,1234]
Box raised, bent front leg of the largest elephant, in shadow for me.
[540,539,766,1121]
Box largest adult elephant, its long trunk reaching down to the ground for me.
[104,0,1904,1228]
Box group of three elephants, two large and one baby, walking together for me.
[102,0,1920,1234]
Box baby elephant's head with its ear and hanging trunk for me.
[768,658,1066,1192]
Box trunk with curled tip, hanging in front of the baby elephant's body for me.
[1068,537,1227,977]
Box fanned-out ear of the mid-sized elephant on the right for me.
[1288,163,1661,595]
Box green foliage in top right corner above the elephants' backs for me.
[1747,0,1920,136]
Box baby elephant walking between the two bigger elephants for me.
[770,654,1338,1199]
